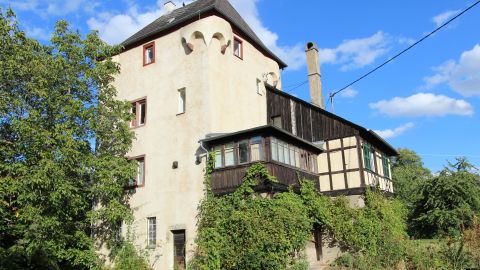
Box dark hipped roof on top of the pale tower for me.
[121,0,287,68]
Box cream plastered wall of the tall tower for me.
[114,16,280,269]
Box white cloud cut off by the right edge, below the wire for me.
[424,44,480,97]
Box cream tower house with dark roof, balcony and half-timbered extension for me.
[114,0,396,269]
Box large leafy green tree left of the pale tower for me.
[0,9,135,269]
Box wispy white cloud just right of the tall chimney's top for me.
[320,31,390,71]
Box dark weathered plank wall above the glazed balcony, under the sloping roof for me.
[267,89,355,142]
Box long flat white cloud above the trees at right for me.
[369,93,474,117]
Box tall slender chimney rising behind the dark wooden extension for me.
[305,42,325,109]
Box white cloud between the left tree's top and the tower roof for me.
[87,0,163,44]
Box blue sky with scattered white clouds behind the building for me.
[0,0,480,171]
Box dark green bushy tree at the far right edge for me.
[412,158,480,237]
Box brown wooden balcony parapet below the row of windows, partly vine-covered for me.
[211,161,319,195]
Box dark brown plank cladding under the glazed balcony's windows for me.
[211,161,318,193]
